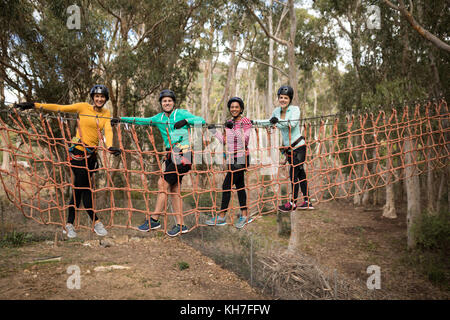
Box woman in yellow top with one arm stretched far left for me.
[15,85,121,238]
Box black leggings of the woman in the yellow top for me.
[67,153,98,224]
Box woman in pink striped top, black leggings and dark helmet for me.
[206,97,253,229]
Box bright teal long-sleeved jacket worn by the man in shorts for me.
[120,109,206,148]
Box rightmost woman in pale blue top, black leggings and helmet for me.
[253,86,314,212]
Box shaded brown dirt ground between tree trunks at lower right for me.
[250,200,450,299]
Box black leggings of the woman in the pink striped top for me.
[220,157,250,211]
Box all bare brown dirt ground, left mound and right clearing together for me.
[0,201,450,300]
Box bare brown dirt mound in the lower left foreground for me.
[0,231,265,300]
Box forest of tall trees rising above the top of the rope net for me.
[0,0,450,290]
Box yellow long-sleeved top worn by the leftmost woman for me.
[34,102,113,150]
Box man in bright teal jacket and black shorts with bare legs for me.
[112,89,206,237]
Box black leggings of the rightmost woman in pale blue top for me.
[287,145,309,203]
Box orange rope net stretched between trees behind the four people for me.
[0,100,450,235]
